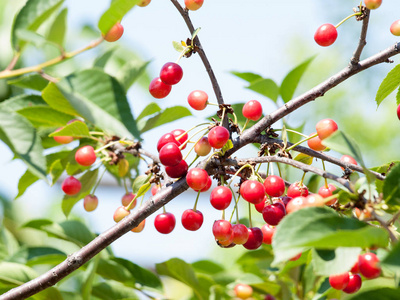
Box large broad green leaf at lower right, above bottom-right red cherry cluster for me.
[272,207,388,264]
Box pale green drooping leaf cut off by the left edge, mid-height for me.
[0,109,47,181]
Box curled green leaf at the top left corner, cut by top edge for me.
[11,0,64,51]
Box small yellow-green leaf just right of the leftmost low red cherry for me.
[61,169,99,217]
